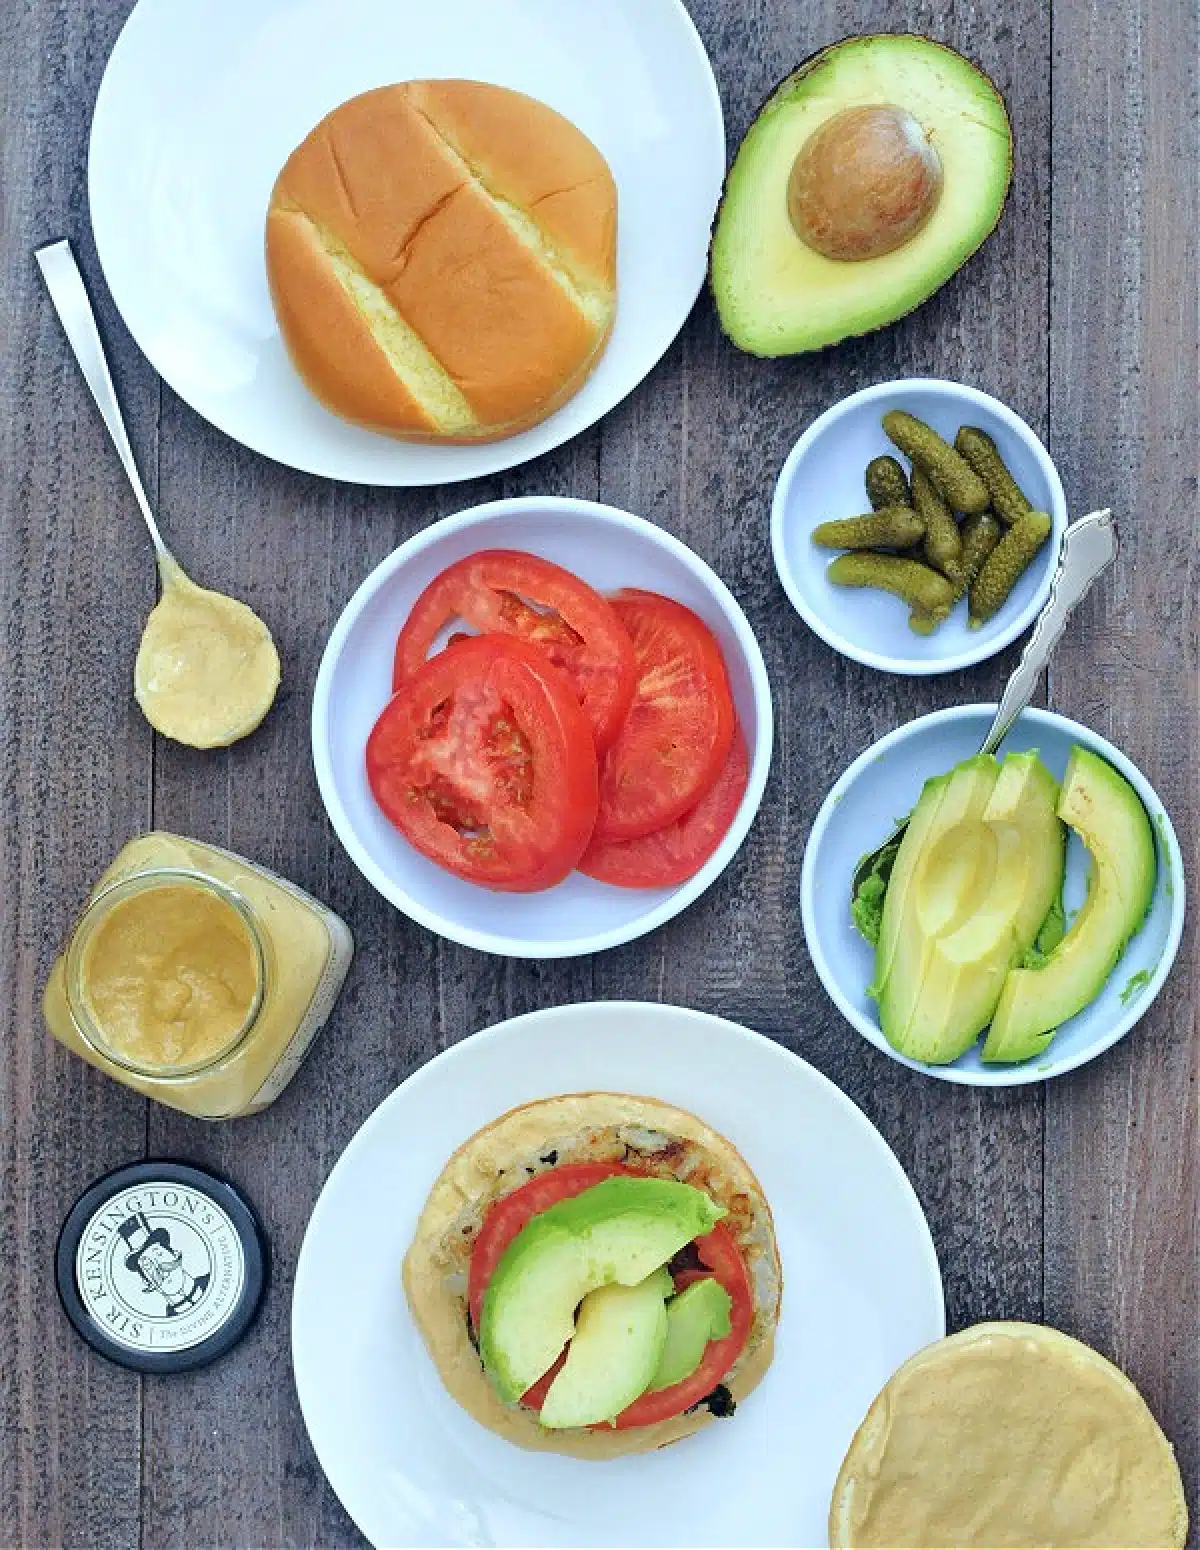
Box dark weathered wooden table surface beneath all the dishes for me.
[0,0,1200,1550]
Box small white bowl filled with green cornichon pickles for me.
[771,378,1067,674]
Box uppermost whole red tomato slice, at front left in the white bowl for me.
[366,636,597,893]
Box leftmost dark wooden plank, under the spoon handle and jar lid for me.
[0,0,158,1547]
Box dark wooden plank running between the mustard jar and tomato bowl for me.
[144,409,595,1550]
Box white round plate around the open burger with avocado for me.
[291,1001,946,1547]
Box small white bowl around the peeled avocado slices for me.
[800,705,1184,1087]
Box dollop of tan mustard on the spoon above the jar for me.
[133,552,279,749]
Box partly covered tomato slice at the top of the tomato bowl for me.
[392,549,636,753]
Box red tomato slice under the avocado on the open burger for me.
[467,1163,753,1428]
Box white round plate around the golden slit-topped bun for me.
[88,0,726,485]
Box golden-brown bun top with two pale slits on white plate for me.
[267,81,617,442]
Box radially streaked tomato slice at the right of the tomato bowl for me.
[595,591,735,840]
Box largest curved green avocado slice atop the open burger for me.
[479,1176,726,1404]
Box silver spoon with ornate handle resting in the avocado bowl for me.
[850,507,1118,905]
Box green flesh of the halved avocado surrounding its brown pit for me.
[710,34,1012,355]
